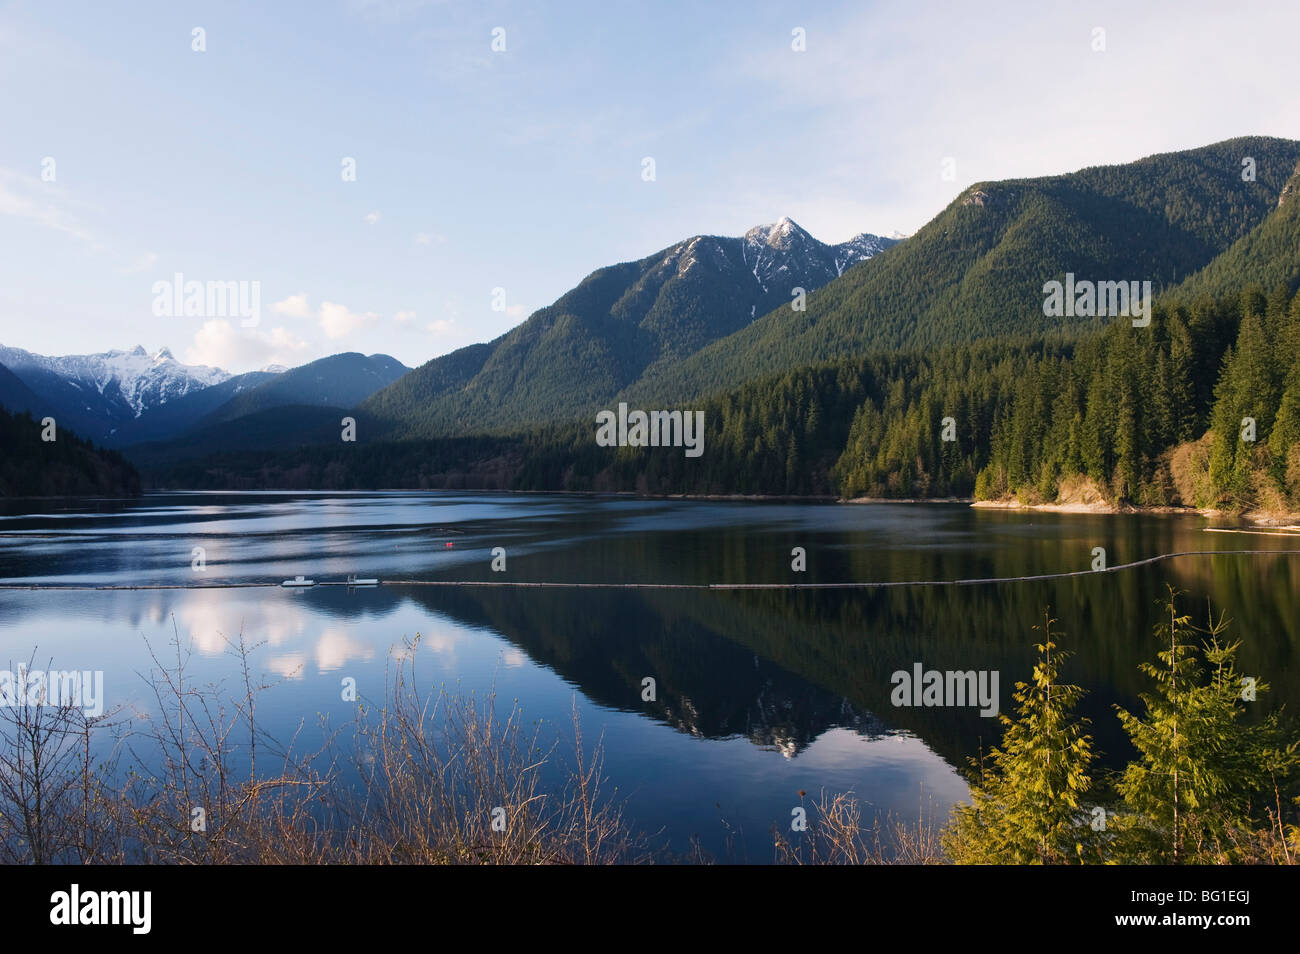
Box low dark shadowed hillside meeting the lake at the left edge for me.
[0,402,140,496]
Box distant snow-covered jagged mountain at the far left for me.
[0,346,230,443]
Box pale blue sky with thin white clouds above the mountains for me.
[0,0,1300,373]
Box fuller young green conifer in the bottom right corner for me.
[1117,587,1296,864]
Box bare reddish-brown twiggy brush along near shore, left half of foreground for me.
[0,639,649,864]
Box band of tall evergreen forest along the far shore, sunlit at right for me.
[144,283,1300,509]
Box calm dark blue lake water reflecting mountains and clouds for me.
[0,493,1300,860]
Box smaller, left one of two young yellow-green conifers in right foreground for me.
[943,615,1095,864]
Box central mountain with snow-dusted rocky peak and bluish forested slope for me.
[364,218,897,437]
